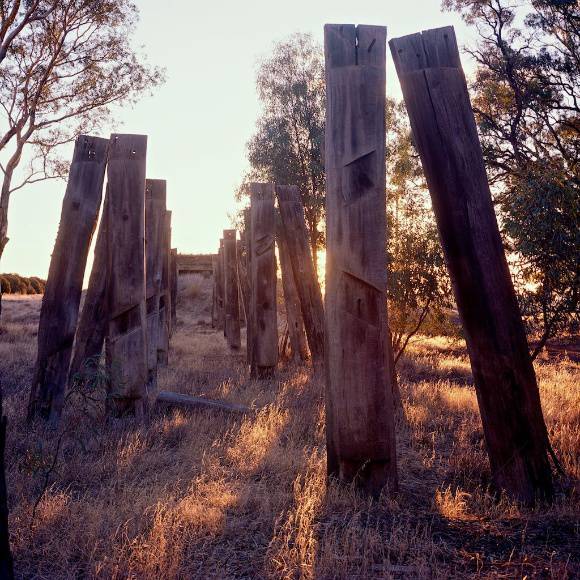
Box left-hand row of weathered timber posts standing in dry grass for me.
[28,134,177,425]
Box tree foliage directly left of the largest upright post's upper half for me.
[242,34,325,260]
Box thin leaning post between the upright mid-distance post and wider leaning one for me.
[277,222,308,361]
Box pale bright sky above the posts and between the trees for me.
[0,0,473,277]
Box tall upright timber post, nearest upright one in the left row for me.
[106,134,148,420]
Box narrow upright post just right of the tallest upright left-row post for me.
[145,179,167,392]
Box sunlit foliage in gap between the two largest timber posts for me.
[386,100,451,360]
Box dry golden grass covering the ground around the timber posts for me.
[0,281,580,579]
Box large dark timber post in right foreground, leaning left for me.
[390,27,552,503]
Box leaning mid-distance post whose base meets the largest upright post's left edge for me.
[276,185,324,364]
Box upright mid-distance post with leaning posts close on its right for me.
[250,183,278,378]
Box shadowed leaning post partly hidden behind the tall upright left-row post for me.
[68,191,109,389]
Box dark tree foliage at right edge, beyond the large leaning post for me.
[443,0,580,356]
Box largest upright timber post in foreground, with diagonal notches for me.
[324,24,397,497]
